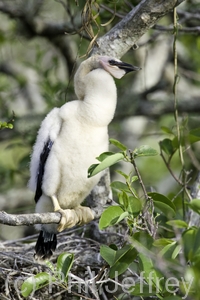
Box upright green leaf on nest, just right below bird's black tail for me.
[57,252,74,281]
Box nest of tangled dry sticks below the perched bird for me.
[0,221,124,300]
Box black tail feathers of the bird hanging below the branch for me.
[34,230,57,260]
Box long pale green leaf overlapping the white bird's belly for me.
[88,152,124,177]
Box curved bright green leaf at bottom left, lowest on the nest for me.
[21,272,52,297]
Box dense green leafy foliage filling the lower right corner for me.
[87,137,200,300]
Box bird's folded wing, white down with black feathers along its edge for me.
[28,108,62,202]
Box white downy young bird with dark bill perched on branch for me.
[29,55,140,259]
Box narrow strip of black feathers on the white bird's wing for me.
[34,139,53,203]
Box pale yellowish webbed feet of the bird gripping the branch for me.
[57,206,94,232]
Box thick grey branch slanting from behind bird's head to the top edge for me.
[92,0,184,58]
